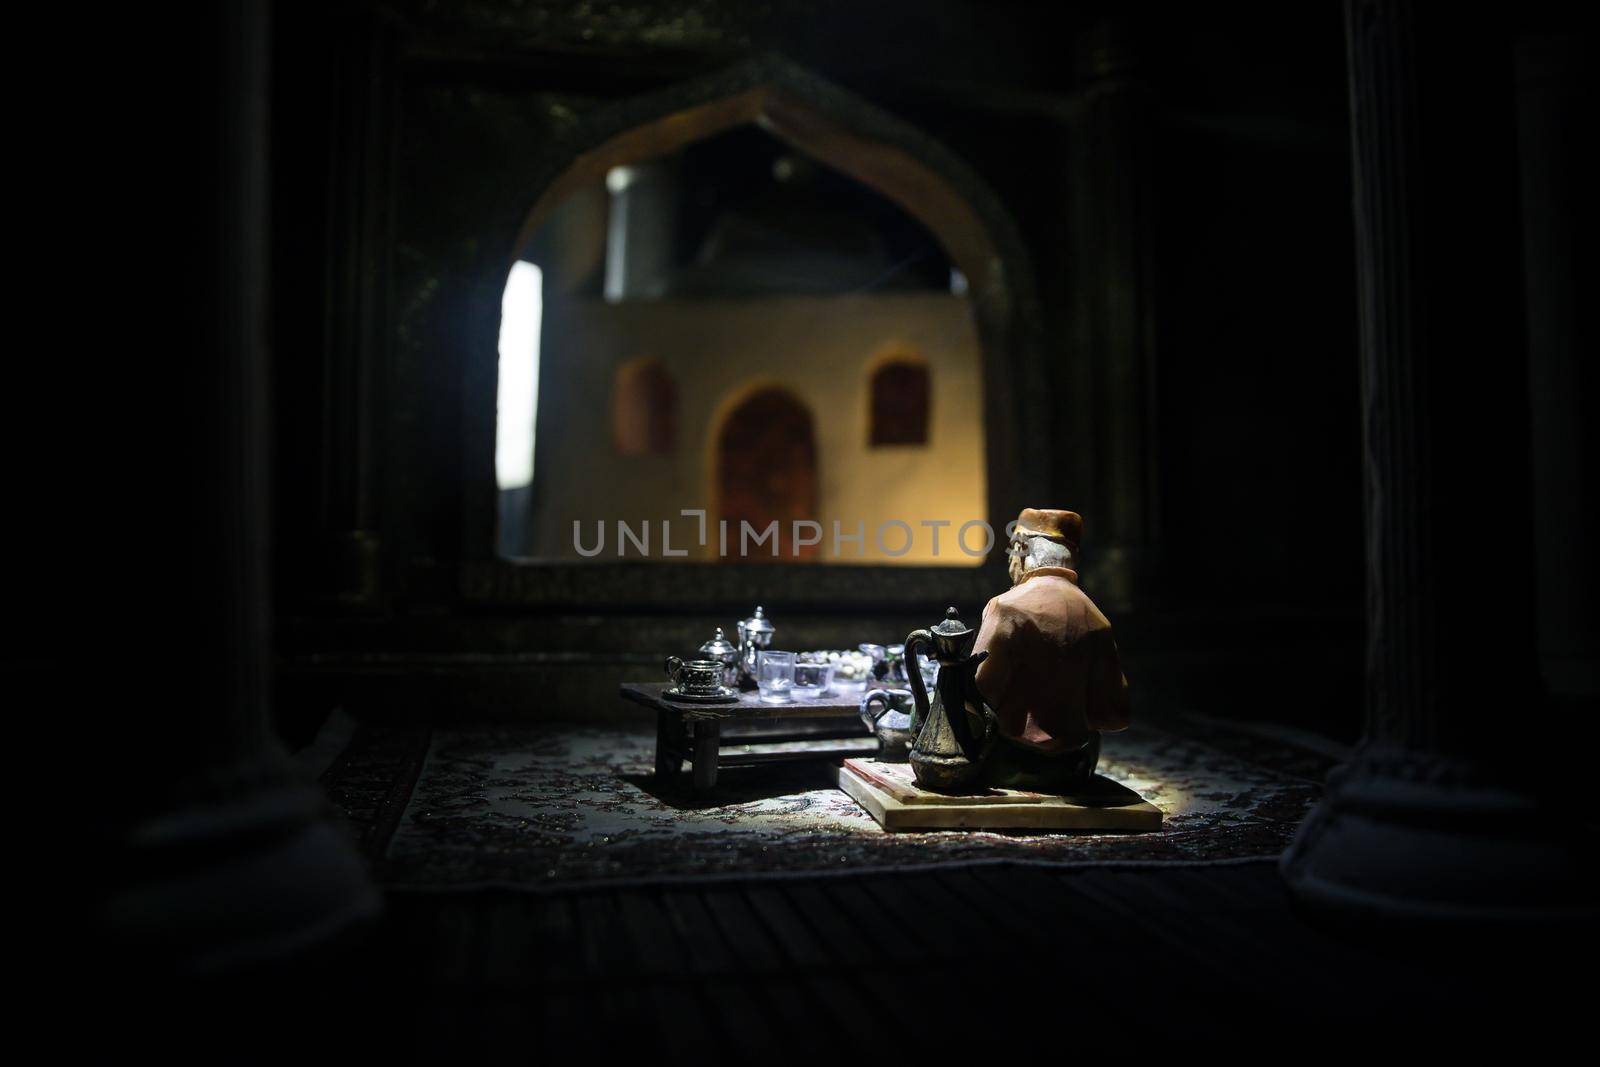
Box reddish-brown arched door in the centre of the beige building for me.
[717,387,821,563]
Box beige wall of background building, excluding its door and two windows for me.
[534,293,986,565]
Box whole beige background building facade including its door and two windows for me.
[530,293,986,566]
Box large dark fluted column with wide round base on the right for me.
[1282,0,1590,918]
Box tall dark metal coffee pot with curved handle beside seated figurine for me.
[906,608,1000,793]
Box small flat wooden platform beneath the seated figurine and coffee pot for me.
[838,760,1162,832]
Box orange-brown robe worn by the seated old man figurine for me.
[973,566,1128,752]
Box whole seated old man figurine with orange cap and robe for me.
[973,507,1128,793]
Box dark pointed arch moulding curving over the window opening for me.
[467,58,1046,601]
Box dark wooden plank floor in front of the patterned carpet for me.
[371,864,1587,1061]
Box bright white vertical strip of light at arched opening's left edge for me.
[494,262,544,490]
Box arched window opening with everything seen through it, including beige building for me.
[499,126,989,566]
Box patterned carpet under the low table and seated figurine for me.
[323,725,1326,888]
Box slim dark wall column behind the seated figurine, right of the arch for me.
[1074,21,1158,613]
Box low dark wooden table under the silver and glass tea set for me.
[622,681,878,790]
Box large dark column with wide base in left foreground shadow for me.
[100,2,378,972]
